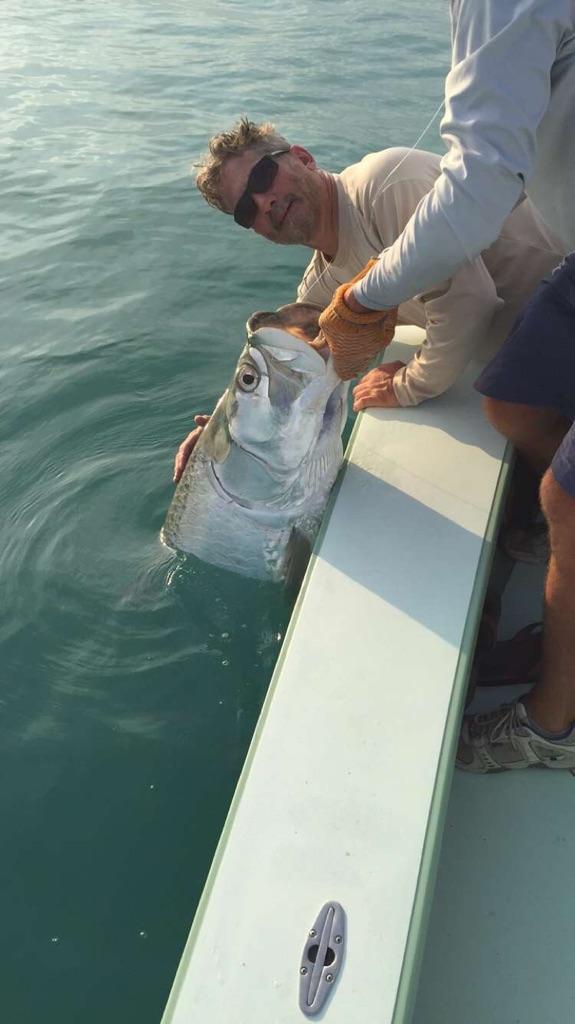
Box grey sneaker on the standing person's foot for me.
[455,700,575,773]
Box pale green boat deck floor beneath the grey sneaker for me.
[412,564,575,1024]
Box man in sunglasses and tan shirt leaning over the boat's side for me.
[175,121,562,479]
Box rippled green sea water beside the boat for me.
[0,0,449,1024]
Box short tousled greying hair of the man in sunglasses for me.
[195,118,290,213]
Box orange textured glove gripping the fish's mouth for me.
[314,259,397,381]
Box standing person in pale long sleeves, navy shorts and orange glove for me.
[320,0,575,772]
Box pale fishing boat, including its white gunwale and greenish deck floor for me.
[163,328,560,1024]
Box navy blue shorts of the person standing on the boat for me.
[475,253,575,498]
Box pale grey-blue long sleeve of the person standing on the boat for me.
[353,0,573,309]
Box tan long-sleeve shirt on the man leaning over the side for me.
[298,147,564,406]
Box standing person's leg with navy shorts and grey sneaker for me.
[457,254,575,772]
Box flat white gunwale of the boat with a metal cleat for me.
[157,329,510,1024]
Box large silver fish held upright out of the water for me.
[162,303,349,583]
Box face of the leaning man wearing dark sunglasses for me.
[220,146,327,248]
